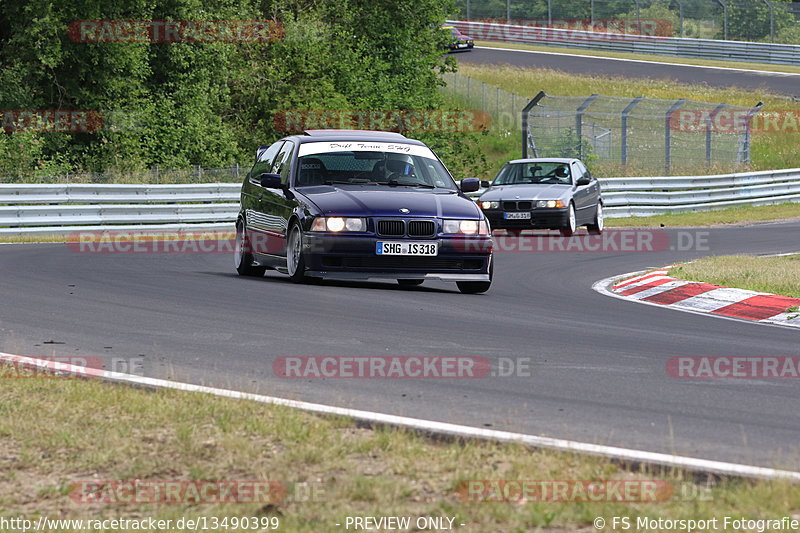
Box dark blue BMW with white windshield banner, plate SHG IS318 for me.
[235,130,493,293]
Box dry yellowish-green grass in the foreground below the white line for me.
[0,378,800,533]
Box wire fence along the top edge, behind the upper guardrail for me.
[456,0,800,44]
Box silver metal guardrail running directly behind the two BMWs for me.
[0,168,800,236]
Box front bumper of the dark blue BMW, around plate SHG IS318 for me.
[303,233,493,281]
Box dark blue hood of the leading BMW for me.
[297,186,482,219]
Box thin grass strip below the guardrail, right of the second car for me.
[606,203,800,227]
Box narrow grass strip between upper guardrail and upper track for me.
[475,41,800,74]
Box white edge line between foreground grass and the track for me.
[0,352,800,482]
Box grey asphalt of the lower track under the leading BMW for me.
[0,222,800,470]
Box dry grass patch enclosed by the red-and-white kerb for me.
[669,254,800,298]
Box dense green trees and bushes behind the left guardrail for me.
[0,0,488,176]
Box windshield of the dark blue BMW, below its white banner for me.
[295,151,456,190]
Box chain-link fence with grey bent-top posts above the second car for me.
[522,92,761,175]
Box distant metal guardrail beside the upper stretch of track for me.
[447,20,800,65]
